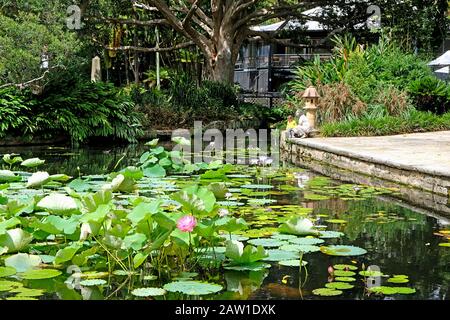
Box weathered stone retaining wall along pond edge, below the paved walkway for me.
[280,134,450,215]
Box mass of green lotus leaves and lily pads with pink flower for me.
[0,140,440,299]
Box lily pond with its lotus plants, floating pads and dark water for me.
[0,145,450,300]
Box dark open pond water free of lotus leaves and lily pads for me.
[0,146,450,300]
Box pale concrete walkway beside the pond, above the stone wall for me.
[292,131,450,177]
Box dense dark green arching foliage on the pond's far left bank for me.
[0,80,142,142]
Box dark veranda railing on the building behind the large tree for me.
[235,53,331,69]
